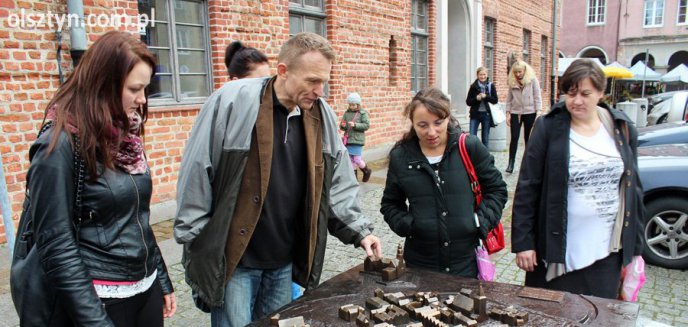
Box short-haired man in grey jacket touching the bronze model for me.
[174,33,382,326]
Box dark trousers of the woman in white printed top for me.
[526,253,622,299]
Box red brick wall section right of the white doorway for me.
[481,0,561,108]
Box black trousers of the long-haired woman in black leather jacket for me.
[101,280,163,327]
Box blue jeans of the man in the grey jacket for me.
[210,263,291,327]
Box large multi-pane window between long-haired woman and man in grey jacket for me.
[138,0,212,106]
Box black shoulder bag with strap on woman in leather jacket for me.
[10,122,84,326]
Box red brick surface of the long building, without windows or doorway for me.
[0,0,551,242]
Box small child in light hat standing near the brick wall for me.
[339,92,372,183]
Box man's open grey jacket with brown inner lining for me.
[174,77,373,309]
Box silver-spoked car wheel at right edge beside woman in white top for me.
[643,197,688,269]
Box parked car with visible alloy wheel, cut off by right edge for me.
[638,144,688,269]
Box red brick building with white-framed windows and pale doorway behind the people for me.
[0,0,552,241]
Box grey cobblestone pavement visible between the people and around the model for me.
[0,152,688,327]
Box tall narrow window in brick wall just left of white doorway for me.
[411,0,428,91]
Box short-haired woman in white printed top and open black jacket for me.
[512,60,644,299]
